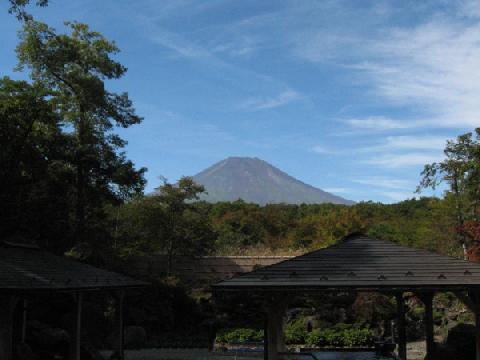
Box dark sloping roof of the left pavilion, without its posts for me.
[0,243,145,291]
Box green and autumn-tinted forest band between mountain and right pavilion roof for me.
[205,198,461,255]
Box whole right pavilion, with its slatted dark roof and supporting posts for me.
[213,234,480,360]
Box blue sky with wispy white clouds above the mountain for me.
[0,0,480,202]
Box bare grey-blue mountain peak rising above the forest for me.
[193,156,353,205]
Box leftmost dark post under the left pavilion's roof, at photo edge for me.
[0,295,18,360]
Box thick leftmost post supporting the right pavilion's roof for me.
[266,296,287,360]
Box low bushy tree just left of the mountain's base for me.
[110,177,215,275]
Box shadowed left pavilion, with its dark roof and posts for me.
[0,242,146,360]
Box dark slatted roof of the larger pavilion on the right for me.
[213,235,480,292]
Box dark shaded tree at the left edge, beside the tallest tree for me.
[0,78,74,250]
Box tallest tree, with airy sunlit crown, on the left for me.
[17,20,146,242]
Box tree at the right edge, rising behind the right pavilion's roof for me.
[417,128,480,255]
